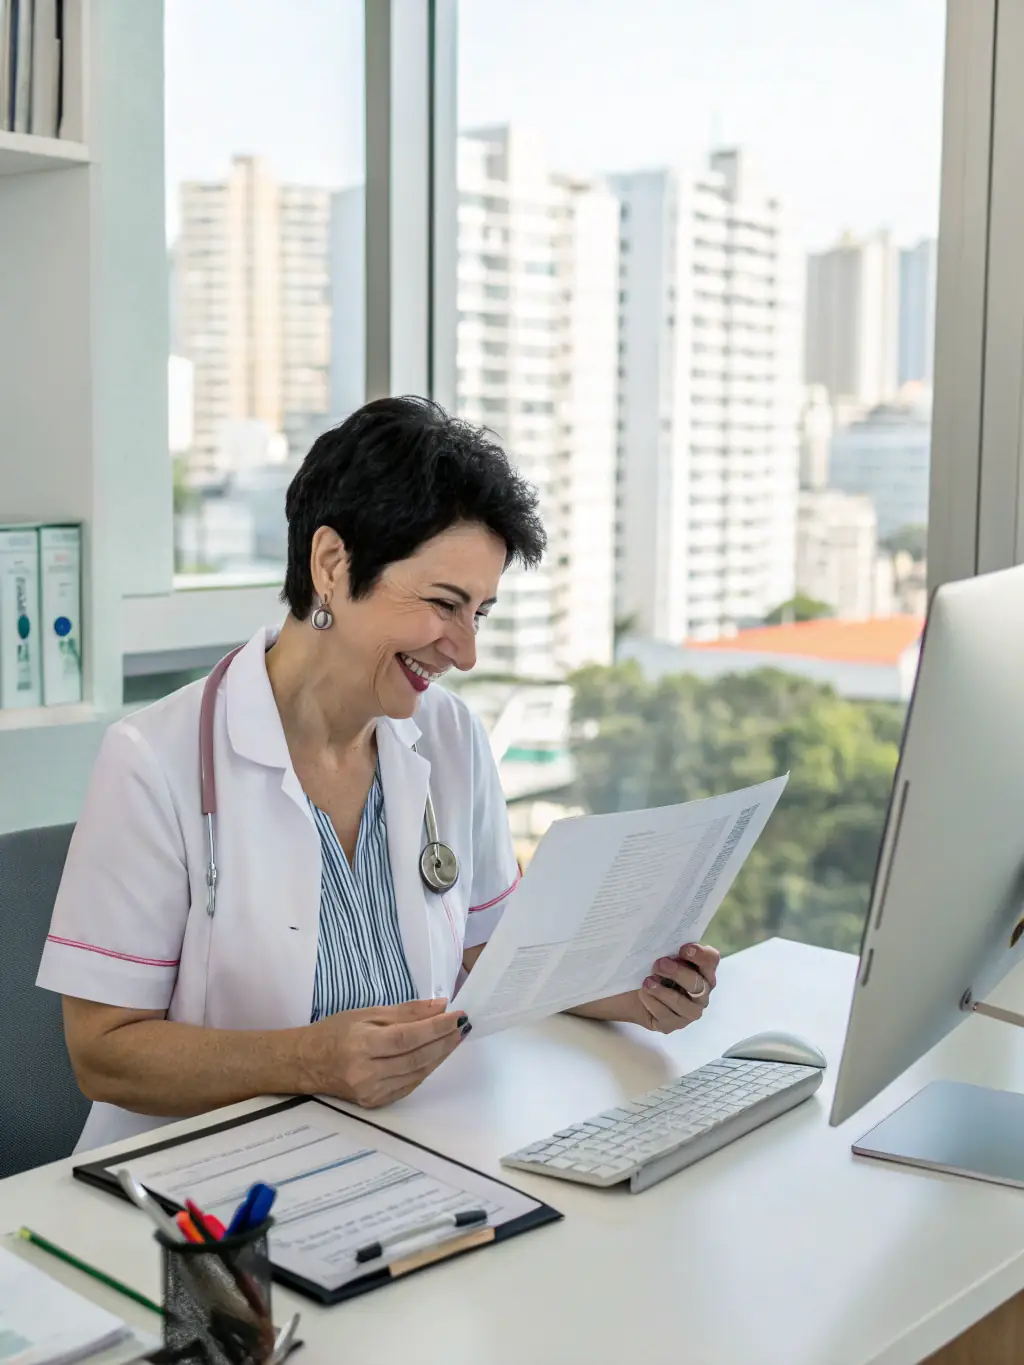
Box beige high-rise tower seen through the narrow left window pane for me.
[173,157,330,475]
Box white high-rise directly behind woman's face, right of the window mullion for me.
[456,127,618,676]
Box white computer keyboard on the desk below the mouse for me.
[501,1057,822,1194]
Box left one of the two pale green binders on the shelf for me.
[0,527,42,709]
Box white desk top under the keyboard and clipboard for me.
[0,939,1024,1365]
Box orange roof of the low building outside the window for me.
[685,616,924,665]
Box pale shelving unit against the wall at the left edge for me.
[0,0,172,833]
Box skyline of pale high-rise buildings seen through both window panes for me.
[173,128,934,649]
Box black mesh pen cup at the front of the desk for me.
[157,1219,274,1365]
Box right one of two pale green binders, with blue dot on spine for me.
[40,526,82,706]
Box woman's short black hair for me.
[281,397,546,620]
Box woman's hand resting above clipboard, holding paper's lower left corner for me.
[300,999,468,1108]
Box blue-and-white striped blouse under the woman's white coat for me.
[310,766,416,1024]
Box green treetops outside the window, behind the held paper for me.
[572,662,904,951]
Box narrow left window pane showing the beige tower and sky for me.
[165,0,363,579]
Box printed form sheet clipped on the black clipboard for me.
[126,1100,538,1290]
